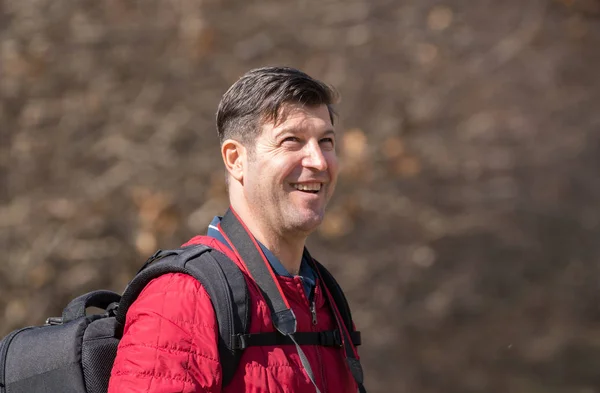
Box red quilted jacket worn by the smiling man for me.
[108,236,357,393]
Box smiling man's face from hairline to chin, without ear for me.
[243,104,338,235]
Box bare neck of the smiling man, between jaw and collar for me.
[232,205,306,276]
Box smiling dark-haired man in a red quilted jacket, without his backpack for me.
[109,67,357,393]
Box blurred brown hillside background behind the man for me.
[0,0,600,393]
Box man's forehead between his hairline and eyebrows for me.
[262,104,333,133]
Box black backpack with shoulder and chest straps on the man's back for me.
[0,245,364,393]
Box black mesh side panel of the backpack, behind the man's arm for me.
[81,337,119,393]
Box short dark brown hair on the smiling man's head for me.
[217,67,338,145]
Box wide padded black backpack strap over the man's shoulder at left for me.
[116,245,250,386]
